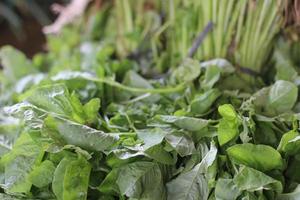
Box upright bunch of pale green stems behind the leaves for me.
[108,0,282,76]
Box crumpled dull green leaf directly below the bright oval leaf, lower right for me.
[233,167,283,194]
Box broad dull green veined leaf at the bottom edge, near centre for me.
[116,161,165,200]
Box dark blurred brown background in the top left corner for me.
[0,0,68,57]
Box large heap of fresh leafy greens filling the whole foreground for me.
[0,0,300,200]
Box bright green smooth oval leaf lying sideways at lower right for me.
[227,143,283,171]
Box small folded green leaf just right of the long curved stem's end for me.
[191,89,221,115]
